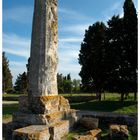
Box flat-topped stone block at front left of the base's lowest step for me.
[13,125,50,140]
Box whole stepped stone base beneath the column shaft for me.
[13,96,77,140]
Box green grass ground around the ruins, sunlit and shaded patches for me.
[3,93,137,140]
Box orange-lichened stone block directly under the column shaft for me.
[31,96,70,114]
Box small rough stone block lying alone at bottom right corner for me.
[110,124,129,139]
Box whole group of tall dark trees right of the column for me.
[79,0,138,101]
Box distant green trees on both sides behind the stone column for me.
[2,52,80,94]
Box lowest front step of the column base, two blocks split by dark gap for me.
[13,121,69,140]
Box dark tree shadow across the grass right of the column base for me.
[71,101,137,112]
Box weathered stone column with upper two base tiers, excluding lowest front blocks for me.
[13,0,70,131]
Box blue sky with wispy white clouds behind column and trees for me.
[2,0,138,82]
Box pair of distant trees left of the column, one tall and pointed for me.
[2,52,28,94]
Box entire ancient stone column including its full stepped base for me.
[10,0,72,140]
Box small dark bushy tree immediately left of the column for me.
[14,72,28,94]
